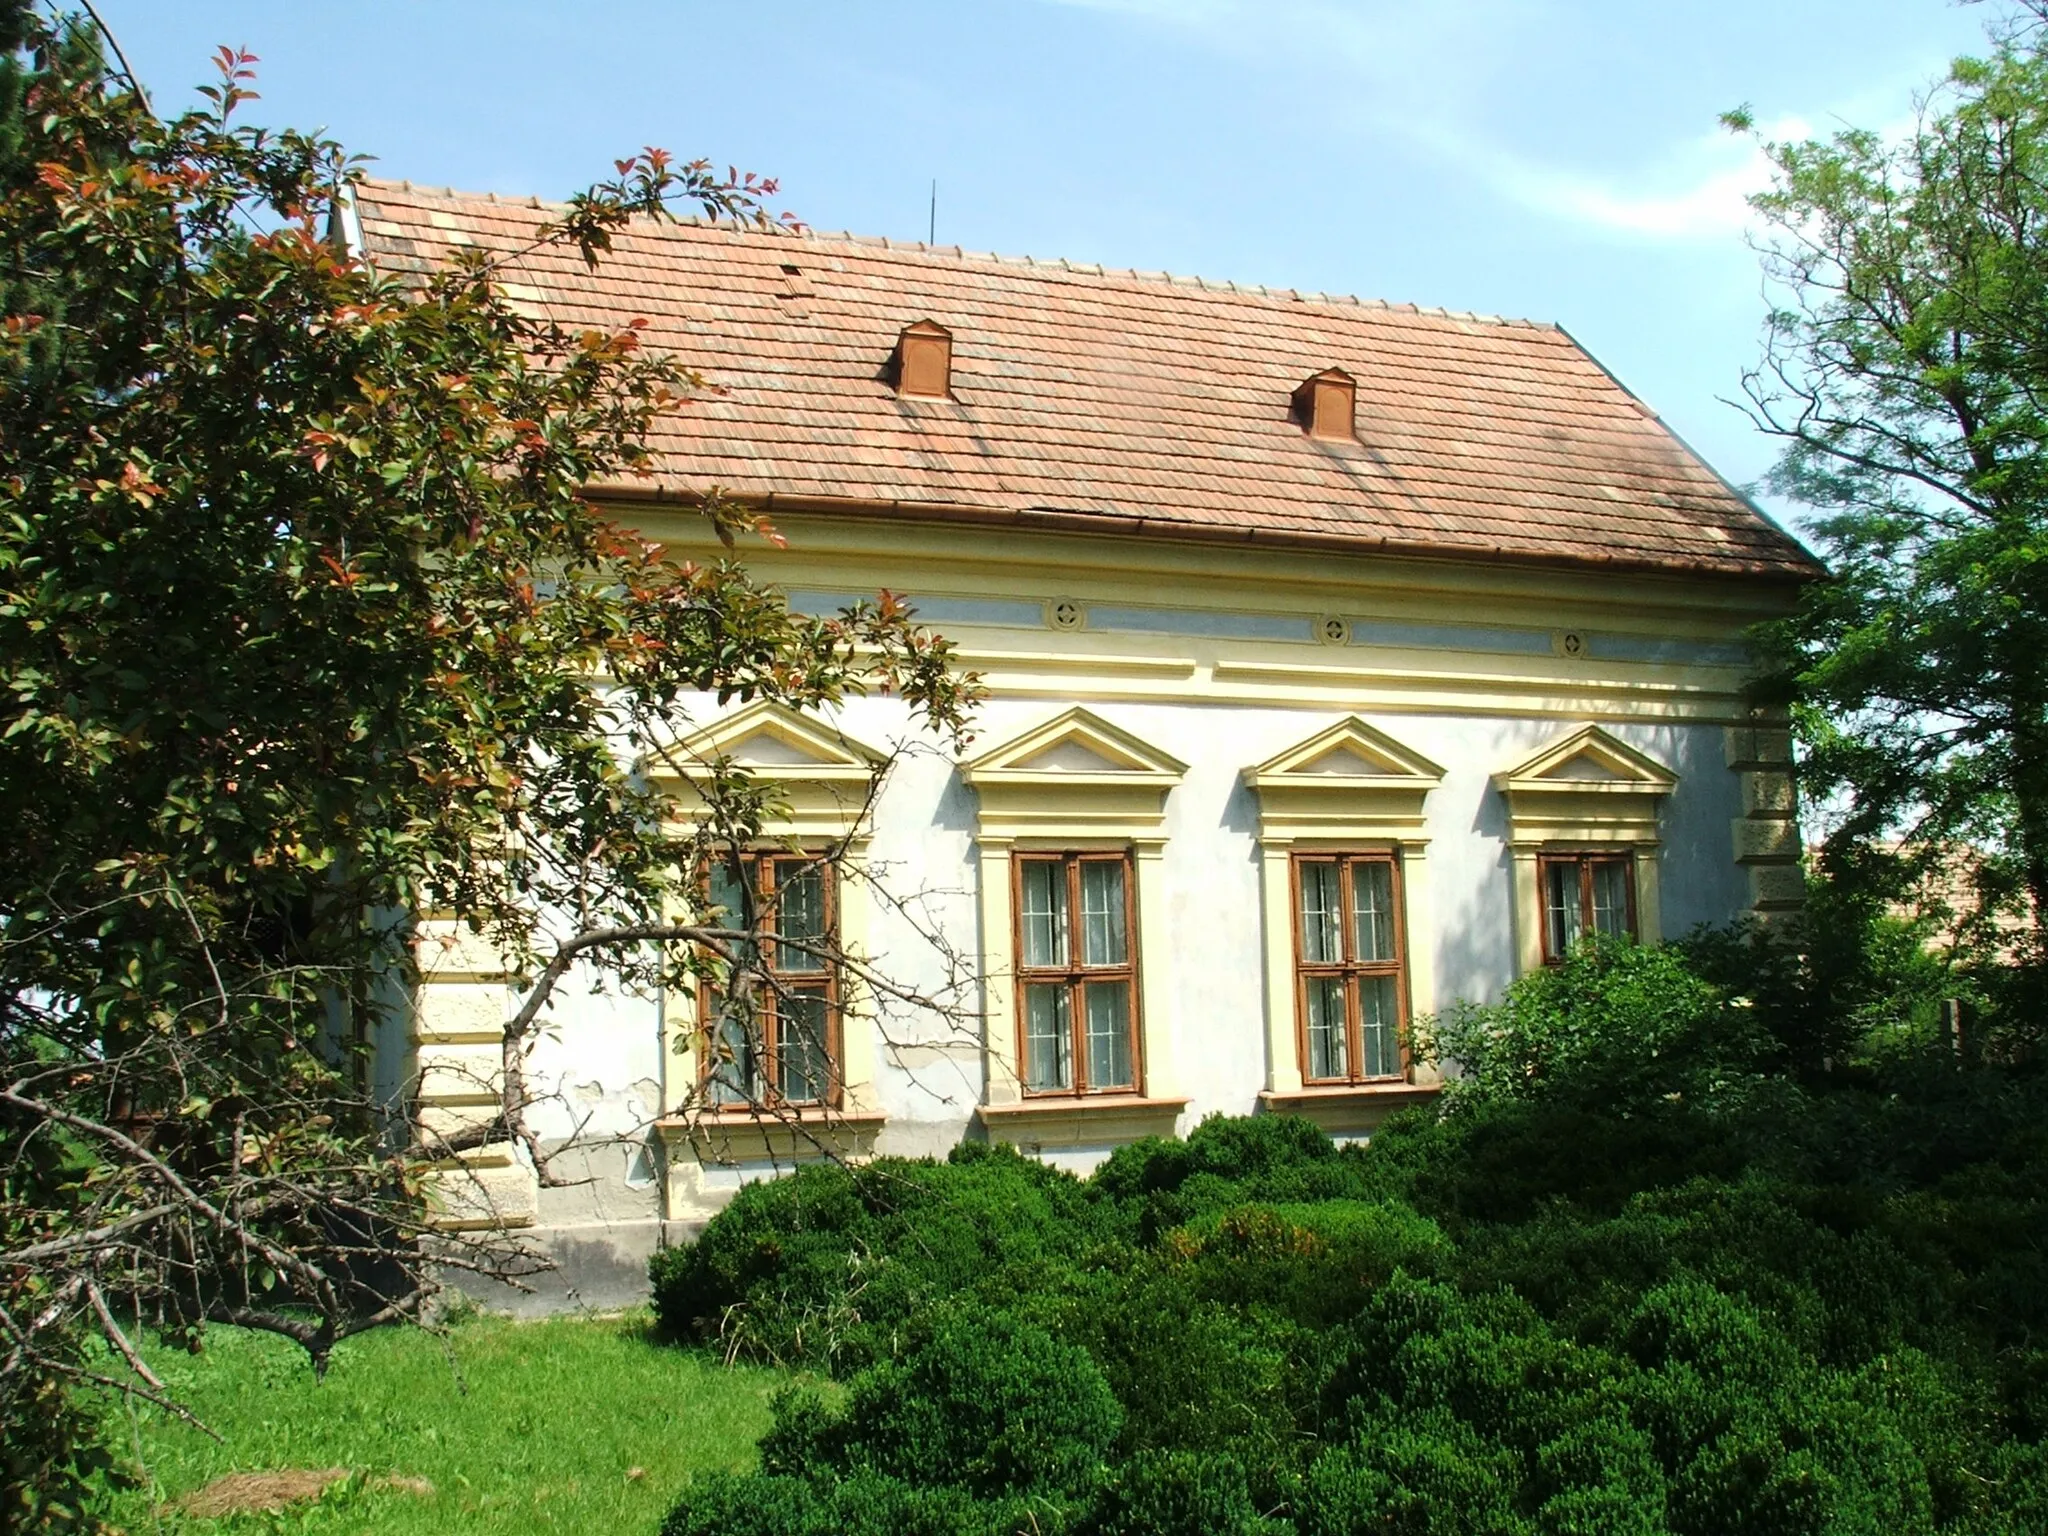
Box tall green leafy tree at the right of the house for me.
[1729,0,2048,946]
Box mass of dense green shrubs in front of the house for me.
[657,940,2048,1536]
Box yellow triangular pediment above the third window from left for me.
[1243,715,1444,842]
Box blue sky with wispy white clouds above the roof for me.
[98,0,1997,518]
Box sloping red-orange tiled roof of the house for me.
[356,182,1821,578]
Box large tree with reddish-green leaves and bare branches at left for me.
[0,6,973,1524]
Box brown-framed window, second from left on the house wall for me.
[1016,854,1139,1094]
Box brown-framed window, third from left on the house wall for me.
[1294,854,1407,1083]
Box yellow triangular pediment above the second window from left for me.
[961,707,1188,838]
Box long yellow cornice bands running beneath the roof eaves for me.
[618,504,1792,725]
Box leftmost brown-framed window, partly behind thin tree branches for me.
[698,852,840,1104]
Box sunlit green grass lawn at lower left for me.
[109,1317,788,1536]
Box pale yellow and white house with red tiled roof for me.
[344,182,1819,1302]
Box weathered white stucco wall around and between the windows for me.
[503,698,1747,1165]
